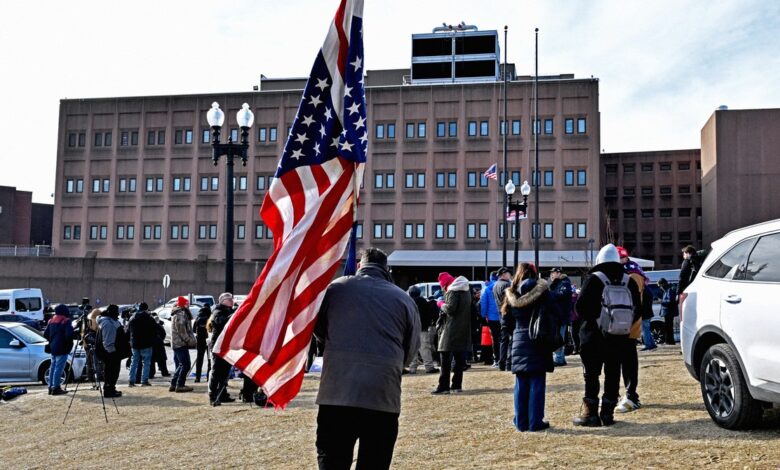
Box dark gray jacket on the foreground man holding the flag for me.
[314,263,420,413]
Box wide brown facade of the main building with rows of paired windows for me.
[53,69,601,268]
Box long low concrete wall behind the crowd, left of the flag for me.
[0,253,263,305]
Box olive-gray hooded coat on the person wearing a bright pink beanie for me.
[438,276,471,352]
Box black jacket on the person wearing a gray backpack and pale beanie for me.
[575,262,642,345]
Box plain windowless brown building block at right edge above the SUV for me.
[701,109,780,246]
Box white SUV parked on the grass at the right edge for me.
[680,219,780,429]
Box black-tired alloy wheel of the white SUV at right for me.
[699,344,763,429]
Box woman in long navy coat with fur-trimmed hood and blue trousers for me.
[502,263,553,431]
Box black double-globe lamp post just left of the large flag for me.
[206,101,255,292]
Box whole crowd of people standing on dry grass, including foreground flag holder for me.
[45,244,699,468]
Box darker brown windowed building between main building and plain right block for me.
[600,149,702,269]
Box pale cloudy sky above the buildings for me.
[0,0,780,202]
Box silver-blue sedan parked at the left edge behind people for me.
[0,323,86,385]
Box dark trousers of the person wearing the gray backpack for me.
[580,339,620,402]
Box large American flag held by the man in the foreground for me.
[214,0,368,408]
